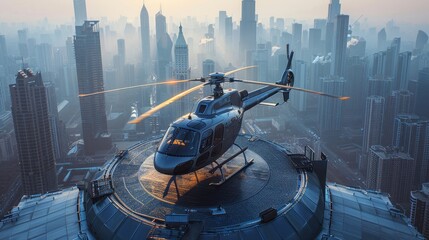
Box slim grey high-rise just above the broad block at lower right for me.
[362,96,385,154]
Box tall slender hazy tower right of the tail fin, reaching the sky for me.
[331,15,349,77]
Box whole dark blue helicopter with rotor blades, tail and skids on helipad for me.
[80,45,349,182]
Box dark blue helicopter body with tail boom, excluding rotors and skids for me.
[154,86,280,175]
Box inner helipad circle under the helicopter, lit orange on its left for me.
[138,144,270,208]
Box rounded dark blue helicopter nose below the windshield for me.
[154,152,194,175]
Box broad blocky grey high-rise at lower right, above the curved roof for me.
[367,145,415,203]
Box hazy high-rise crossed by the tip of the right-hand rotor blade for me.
[318,77,345,134]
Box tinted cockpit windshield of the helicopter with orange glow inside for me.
[158,127,200,157]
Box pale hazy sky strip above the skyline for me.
[0,0,429,25]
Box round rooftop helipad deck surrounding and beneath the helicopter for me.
[112,136,302,229]
